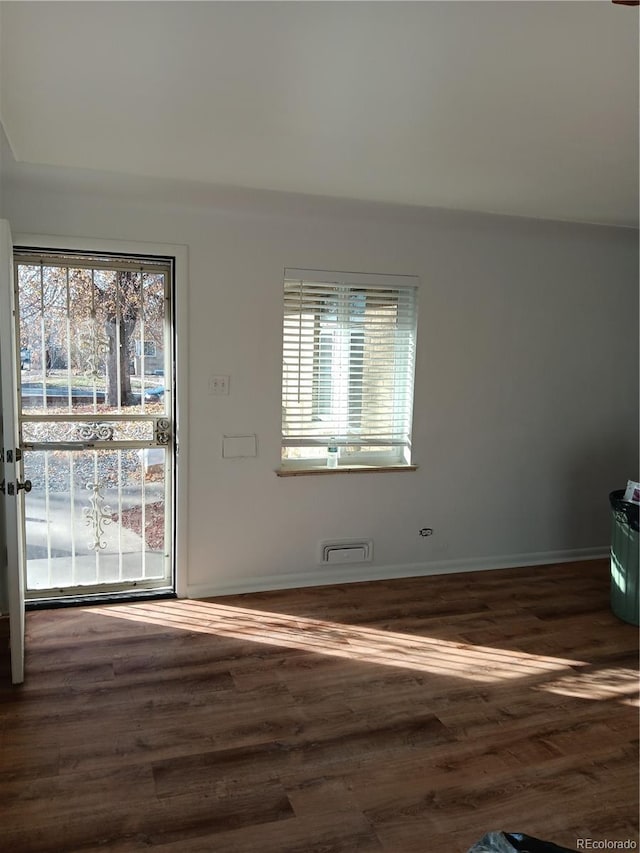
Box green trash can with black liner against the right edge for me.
[609,489,640,625]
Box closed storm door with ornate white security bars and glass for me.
[14,249,174,601]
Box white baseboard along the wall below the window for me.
[187,546,609,598]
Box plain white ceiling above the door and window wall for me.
[0,0,638,225]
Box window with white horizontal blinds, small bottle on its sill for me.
[282,269,418,467]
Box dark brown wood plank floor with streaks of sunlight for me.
[0,561,638,853]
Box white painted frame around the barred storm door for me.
[13,233,189,598]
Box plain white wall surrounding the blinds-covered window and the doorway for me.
[5,168,638,594]
